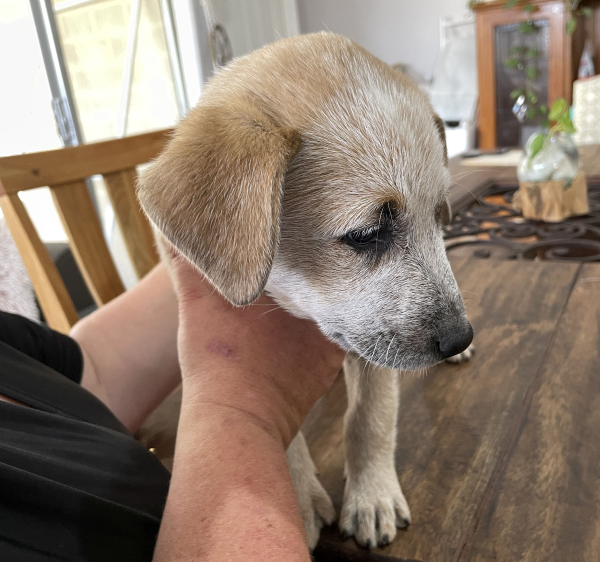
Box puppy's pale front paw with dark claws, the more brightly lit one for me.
[340,469,410,548]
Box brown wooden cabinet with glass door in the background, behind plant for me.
[474,0,600,149]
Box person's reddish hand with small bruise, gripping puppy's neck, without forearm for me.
[171,252,344,447]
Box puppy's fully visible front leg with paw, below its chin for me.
[340,354,410,548]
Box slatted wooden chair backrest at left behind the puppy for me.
[0,130,171,333]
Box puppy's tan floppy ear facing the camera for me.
[138,100,300,305]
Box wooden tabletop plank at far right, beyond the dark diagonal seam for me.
[460,264,600,562]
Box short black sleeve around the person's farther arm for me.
[0,311,83,383]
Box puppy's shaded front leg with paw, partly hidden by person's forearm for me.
[287,431,335,551]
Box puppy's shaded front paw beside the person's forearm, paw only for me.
[294,464,336,551]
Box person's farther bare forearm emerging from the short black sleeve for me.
[71,264,181,432]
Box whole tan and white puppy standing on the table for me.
[139,33,472,548]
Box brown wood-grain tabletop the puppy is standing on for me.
[306,259,600,562]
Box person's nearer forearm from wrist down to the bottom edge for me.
[154,376,310,562]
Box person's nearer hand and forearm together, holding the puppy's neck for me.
[154,252,344,562]
